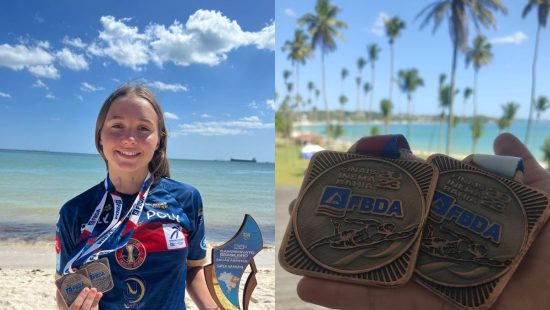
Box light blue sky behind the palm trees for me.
[275,0,550,119]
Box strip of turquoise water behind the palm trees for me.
[299,120,550,161]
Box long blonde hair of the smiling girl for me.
[95,85,170,179]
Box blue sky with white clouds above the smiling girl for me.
[0,0,275,162]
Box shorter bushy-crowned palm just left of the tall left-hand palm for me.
[283,29,312,114]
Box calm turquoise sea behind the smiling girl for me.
[0,150,275,245]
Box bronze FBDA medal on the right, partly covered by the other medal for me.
[415,155,549,309]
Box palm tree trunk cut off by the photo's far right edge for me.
[521,0,550,145]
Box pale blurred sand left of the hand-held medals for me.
[275,188,326,310]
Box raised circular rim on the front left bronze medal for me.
[291,156,428,274]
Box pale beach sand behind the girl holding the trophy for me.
[0,241,275,310]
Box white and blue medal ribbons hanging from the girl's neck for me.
[63,172,153,275]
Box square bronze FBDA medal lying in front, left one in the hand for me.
[279,149,437,287]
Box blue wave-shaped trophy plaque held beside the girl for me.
[204,214,263,310]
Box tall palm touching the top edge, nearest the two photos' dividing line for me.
[298,0,347,143]
